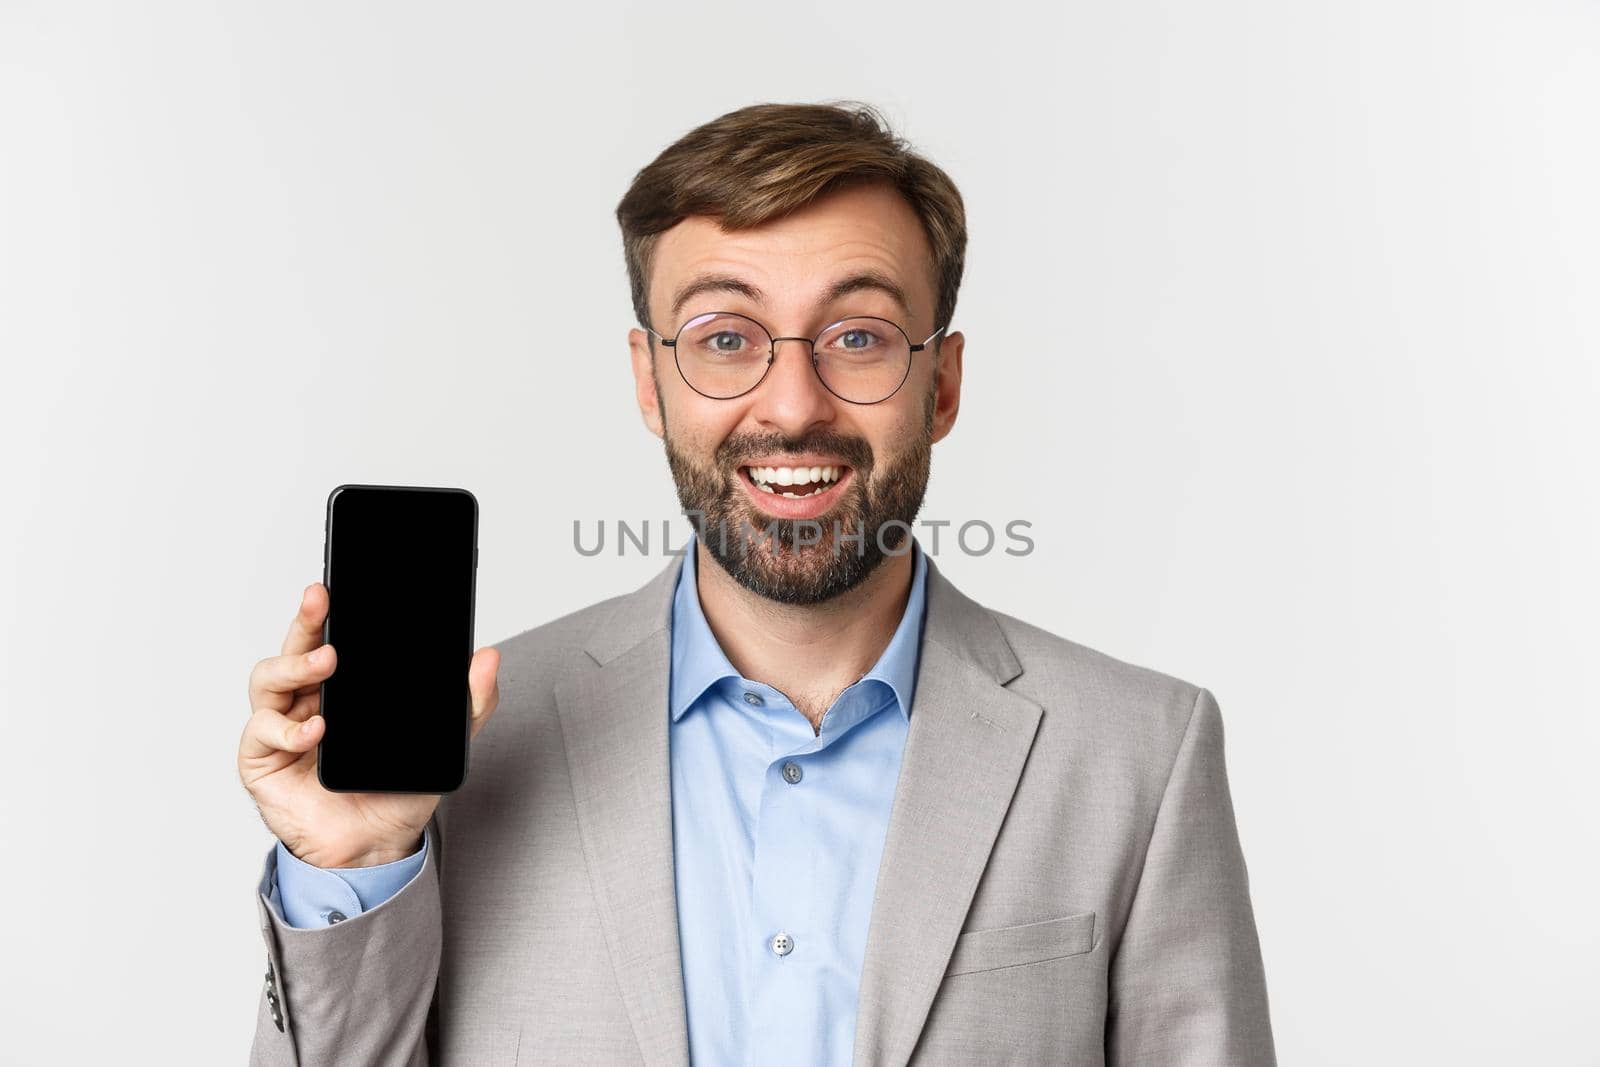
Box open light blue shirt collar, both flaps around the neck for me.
[670,534,928,721]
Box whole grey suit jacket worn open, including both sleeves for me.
[251,558,1274,1067]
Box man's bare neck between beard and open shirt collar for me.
[694,541,912,733]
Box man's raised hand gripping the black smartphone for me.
[238,582,499,867]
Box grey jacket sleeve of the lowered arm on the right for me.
[1106,689,1277,1067]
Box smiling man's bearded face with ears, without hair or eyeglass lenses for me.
[629,184,965,603]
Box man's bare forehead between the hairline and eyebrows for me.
[650,182,933,320]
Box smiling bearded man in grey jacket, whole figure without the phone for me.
[240,104,1274,1067]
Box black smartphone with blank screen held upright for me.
[317,485,478,793]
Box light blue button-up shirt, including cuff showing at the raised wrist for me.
[272,541,928,1065]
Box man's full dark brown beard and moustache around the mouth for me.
[662,390,934,605]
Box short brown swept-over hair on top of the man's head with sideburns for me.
[616,101,966,344]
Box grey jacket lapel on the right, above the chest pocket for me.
[854,558,1042,1067]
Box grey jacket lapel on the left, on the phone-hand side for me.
[555,560,688,1067]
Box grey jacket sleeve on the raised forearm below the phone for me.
[250,813,443,1067]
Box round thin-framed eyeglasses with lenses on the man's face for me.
[646,312,944,403]
